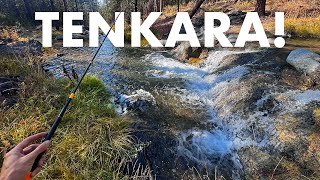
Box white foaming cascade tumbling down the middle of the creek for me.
[146,51,252,175]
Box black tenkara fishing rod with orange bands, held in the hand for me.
[25,13,121,180]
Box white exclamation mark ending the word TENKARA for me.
[274,12,286,48]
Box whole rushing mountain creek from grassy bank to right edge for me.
[39,37,320,179]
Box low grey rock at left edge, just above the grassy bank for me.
[0,40,42,56]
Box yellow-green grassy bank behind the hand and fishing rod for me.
[0,59,144,179]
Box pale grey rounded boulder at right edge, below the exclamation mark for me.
[287,49,320,75]
